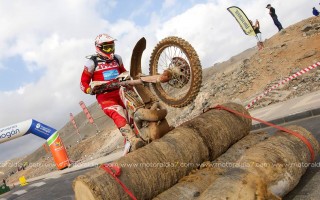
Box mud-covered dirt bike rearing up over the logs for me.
[91,37,202,151]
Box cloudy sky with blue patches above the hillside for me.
[0,0,319,161]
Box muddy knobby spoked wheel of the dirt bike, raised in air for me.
[149,36,202,108]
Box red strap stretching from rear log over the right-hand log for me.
[205,105,315,162]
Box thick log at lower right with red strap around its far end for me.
[199,125,319,200]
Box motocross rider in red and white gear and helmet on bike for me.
[80,34,144,151]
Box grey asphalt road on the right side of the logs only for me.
[252,115,320,200]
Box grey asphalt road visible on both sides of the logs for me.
[0,115,320,200]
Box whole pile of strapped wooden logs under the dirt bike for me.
[73,103,319,200]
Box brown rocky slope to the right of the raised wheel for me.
[168,17,320,124]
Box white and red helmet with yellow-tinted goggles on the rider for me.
[95,34,116,60]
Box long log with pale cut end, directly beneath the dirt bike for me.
[73,103,251,200]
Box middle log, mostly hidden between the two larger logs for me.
[154,132,269,200]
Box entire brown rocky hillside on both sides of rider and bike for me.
[0,17,320,185]
